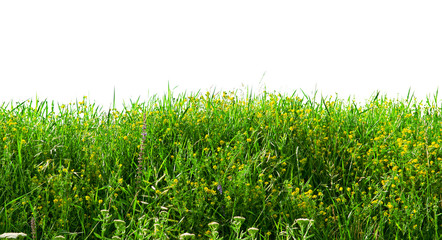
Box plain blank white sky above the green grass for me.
[0,0,442,108]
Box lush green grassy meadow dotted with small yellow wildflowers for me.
[0,88,442,240]
